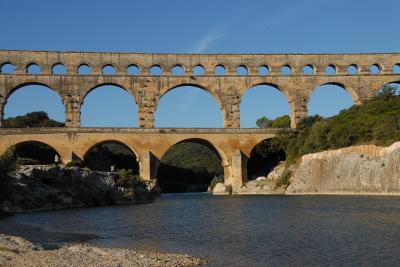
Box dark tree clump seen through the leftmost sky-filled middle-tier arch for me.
[3,111,65,128]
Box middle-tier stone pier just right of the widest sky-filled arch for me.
[221,95,240,128]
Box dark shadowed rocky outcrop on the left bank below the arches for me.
[0,166,159,212]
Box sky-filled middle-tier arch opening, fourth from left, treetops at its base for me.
[240,83,291,128]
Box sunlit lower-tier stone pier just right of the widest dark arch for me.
[225,149,248,193]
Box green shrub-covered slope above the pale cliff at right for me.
[270,86,400,162]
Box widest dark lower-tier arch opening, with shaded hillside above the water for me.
[157,138,227,193]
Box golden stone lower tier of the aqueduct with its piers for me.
[0,128,276,191]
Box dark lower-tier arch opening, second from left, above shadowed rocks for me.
[82,139,139,174]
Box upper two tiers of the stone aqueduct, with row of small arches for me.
[0,50,400,128]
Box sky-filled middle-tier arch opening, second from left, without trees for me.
[81,83,138,127]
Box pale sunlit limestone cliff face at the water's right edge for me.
[286,142,400,195]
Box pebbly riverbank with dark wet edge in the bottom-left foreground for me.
[0,221,204,267]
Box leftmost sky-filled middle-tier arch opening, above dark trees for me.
[0,82,65,125]
